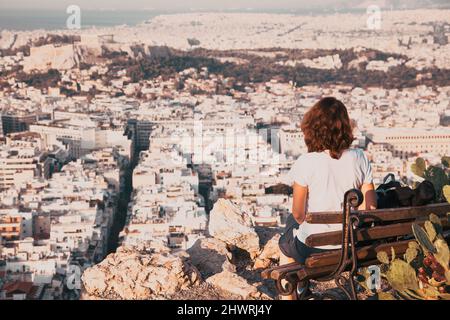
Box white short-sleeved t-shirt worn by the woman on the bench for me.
[286,149,373,249]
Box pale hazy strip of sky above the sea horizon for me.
[0,0,355,10]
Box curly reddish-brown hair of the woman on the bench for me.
[301,97,355,159]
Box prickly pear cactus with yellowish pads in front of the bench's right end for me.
[377,215,450,300]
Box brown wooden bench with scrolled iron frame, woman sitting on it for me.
[262,189,450,300]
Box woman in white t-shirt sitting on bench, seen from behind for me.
[279,97,376,300]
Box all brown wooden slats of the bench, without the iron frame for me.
[261,203,450,292]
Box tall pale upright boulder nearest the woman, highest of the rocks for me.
[208,199,260,258]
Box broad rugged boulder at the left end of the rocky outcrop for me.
[82,247,201,299]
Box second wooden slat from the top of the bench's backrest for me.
[305,218,448,247]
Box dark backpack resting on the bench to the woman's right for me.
[376,173,436,209]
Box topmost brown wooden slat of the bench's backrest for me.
[306,203,450,224]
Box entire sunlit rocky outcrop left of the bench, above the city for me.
[82,199,279,299]
